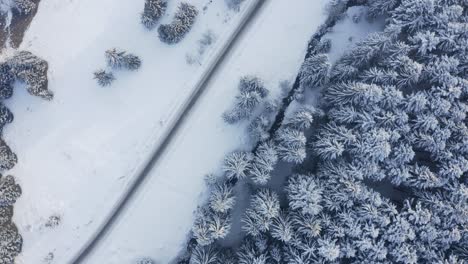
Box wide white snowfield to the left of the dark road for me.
[4,0,254,263]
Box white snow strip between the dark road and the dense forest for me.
[82,0,327,264]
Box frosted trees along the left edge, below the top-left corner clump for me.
[0,51,53,264]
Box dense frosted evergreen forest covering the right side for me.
[182,0,468,264]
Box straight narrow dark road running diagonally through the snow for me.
[70,0,268,263]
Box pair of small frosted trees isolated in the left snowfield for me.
[94,48,141,86]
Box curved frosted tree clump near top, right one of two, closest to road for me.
[158,3,198,44]
